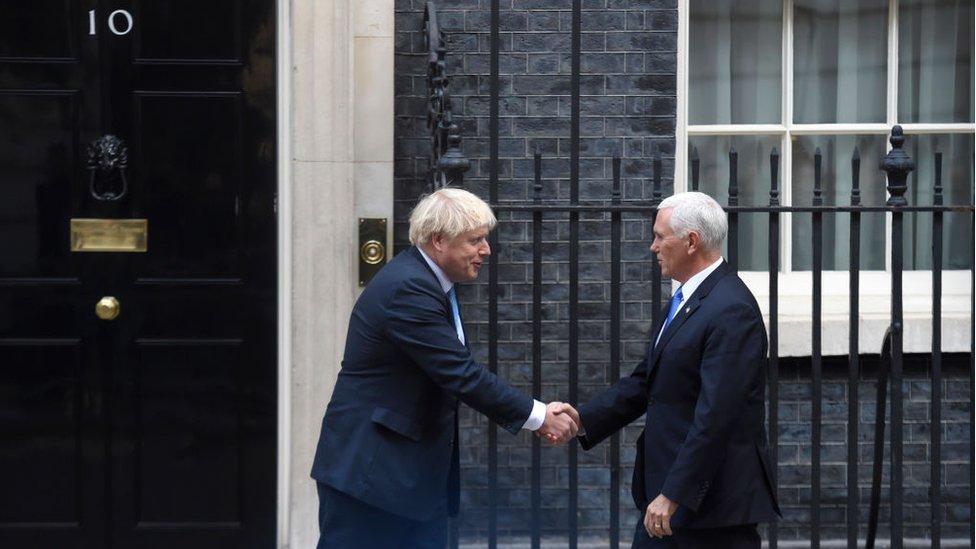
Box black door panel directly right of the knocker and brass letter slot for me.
[135,92,246,278]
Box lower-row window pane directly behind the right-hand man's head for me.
[688,135,782,271]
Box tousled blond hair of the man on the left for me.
[410,187,497,246]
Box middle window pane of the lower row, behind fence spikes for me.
[792,135,887,271]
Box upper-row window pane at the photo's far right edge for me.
[898,0,973,123]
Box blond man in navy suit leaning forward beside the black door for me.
[312,188,577,549]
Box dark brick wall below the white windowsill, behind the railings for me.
[778,354,972,539]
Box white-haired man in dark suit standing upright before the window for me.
[567,192,779,549]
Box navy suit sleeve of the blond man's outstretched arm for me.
[385,280,534,434]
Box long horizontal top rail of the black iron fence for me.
[491,201,974,213]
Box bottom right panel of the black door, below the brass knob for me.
[135,339,243,524]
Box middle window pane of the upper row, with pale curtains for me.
[793,0,888,124]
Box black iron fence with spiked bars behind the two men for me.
[425,0,976,549]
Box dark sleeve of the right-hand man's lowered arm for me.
[661,304,766,511]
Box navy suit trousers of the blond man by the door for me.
[317,482,447,549]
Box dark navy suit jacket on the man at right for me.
[579,262,779,528]
